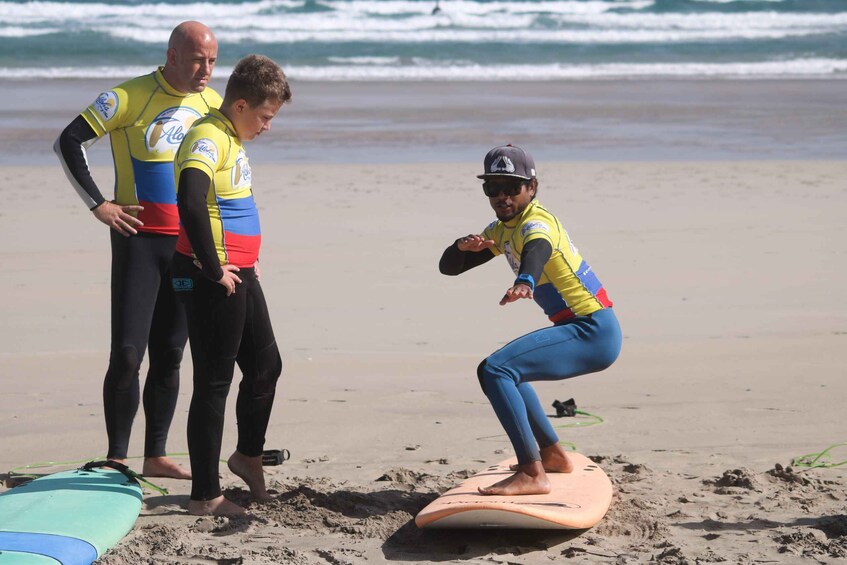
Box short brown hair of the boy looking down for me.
[224,55,291,108]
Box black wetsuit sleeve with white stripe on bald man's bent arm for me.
[53,116,106,210]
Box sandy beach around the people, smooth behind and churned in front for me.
[0,77,847,565]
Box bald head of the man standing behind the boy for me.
[162,21,218,92]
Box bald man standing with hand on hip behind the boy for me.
[53,21,221,479]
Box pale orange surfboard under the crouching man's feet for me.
[415,453,612,530]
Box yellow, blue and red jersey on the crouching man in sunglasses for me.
[482,200,612,323]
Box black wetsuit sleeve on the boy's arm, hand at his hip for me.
[176,168,224,281]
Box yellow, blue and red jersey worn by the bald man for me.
[82,67,221,235]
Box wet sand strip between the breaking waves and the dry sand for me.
[0,78,847,165]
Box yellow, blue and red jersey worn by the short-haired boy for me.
[174,110,262,268]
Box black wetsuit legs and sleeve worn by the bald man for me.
[54,116,188,459]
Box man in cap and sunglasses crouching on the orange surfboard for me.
[439,145,621,495]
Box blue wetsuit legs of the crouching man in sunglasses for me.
[478,308,622,465]
